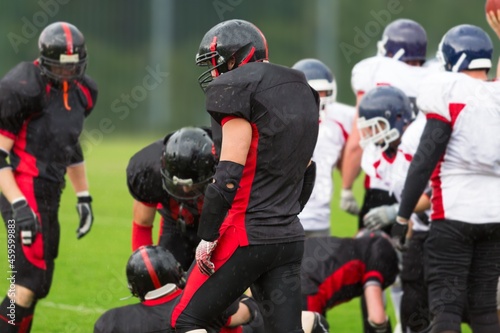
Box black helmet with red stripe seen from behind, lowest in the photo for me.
[126,245,186,300]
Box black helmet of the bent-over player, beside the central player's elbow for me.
[161,127,216,200]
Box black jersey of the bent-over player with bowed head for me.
[127,139,203,226]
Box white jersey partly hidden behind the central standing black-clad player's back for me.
[299,103,356,231]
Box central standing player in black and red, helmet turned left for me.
[172,20,319,333]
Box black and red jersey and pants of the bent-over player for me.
[127,139,203,271]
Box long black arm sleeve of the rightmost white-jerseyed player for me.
[398,119,452,219]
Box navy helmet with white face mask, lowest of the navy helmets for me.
[357,86,413,150]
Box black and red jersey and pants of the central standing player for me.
[172,63,319,332]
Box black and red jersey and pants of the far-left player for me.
[0,61,97,299]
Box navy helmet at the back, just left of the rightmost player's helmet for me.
[377,19,427,63]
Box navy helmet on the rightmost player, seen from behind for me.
[438,24,493,72]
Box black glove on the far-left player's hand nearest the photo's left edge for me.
[12,199,41,246]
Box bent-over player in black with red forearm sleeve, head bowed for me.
[127,127,216,270]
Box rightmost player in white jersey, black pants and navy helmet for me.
[397,25,500,333]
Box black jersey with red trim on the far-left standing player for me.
[0,62,97,182]
